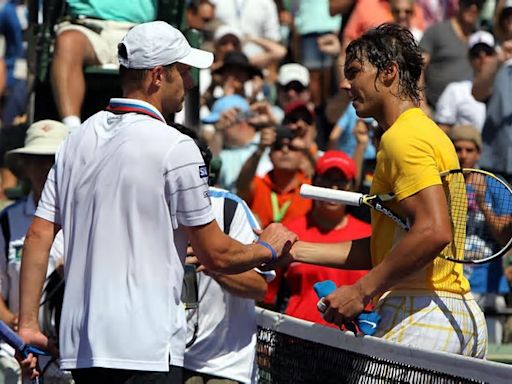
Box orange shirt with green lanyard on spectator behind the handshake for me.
[248,171,312,227]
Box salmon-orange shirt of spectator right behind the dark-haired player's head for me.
[343,0,425,41]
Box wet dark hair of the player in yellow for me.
[345,23,423,104]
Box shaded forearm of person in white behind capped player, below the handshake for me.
[211,271,267,301]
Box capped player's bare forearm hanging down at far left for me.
[19,226,53,330]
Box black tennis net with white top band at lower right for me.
[256,308,512,384]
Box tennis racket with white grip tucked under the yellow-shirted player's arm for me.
[300,168,512,264]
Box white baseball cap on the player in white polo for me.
[117,21,213,69]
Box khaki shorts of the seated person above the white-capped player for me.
[56,18,136,66]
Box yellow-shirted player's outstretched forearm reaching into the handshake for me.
[291,237,372,270]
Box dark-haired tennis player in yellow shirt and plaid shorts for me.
[268,24,487,358]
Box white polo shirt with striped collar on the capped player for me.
[36,99,214,371]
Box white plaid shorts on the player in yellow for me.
[375,291,487,359]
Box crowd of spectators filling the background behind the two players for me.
[0,0,512,382]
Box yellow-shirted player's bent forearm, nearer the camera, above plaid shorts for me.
[356,226,451,299]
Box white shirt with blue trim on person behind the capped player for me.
[184,187,275,383]
